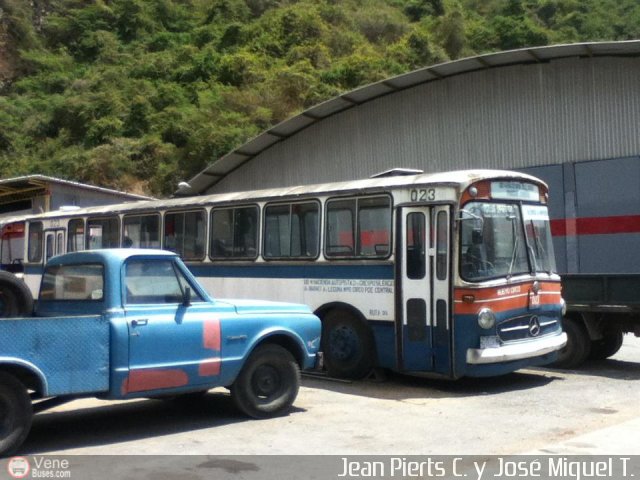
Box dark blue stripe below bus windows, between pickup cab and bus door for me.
[187,263,394,280]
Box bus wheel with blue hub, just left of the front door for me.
[322,310,374,379]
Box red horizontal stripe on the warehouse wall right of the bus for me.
[551,215,640,237]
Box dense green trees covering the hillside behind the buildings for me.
[0,0,640,195]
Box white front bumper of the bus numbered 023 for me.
[467,332,567,365]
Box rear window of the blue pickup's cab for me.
[40,264,104,301]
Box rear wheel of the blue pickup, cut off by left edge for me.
[0,372,33,455]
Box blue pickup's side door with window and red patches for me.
[123,257,220,394]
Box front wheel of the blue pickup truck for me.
[231,344,300,418]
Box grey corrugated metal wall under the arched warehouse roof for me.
[211,57,640,192]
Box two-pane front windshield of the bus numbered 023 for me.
[460,202,555,282]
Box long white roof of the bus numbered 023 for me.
[16,169,546,219]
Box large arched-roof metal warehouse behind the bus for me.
[182,41,640,278]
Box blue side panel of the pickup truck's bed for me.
[0,315,109,396]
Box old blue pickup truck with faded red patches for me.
[0,249,321,455]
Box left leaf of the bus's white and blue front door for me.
[396,207,433,371]
